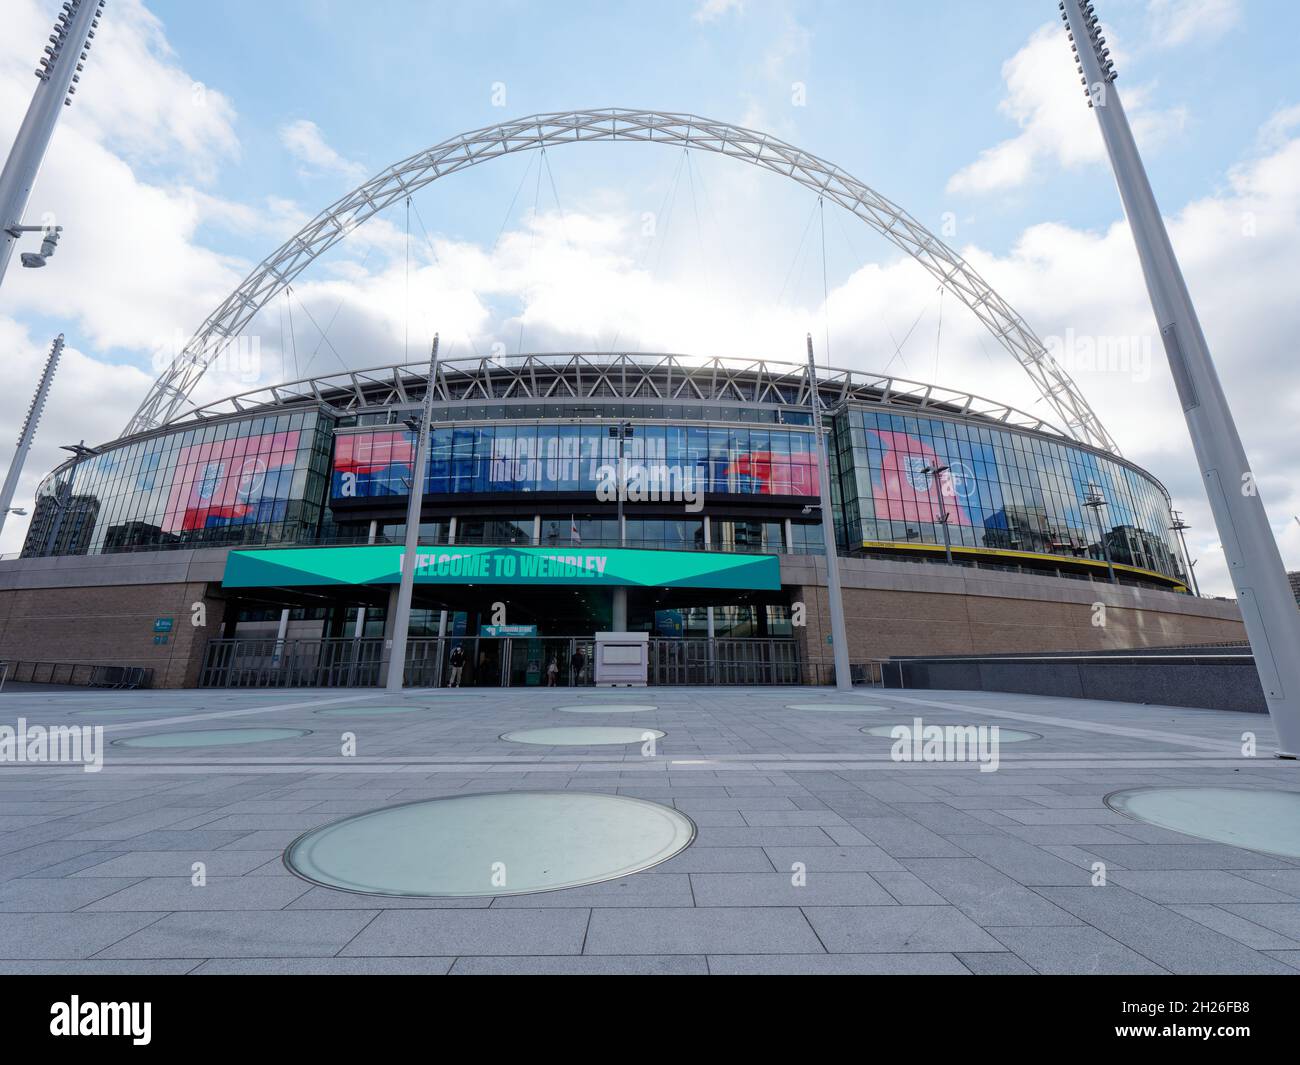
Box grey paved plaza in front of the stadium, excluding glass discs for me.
[0,688,1300,974]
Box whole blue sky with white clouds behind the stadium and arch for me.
[0,0,1300,592]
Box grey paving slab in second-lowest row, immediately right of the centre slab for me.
[805,905,1001,954]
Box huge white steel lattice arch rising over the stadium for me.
[126,108,1119,454]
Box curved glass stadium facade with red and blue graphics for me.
[23,361,1183,586]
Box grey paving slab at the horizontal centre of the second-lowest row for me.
[584,906,823,954]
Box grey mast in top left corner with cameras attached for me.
[0,0,105,291]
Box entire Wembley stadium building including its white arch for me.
[0,111,1242,687]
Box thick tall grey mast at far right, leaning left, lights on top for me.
[1058,0,1300,758]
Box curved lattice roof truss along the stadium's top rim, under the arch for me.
[173,352,1065,438]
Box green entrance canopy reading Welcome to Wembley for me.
[221,544,781,592]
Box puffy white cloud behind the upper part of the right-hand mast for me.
[948,23,1187,194]
